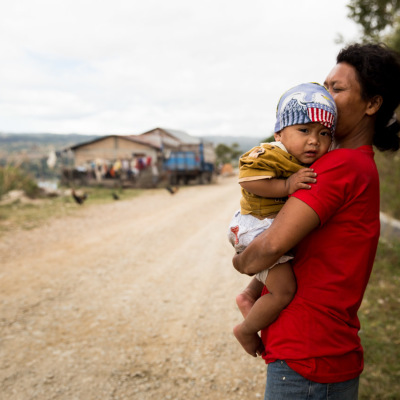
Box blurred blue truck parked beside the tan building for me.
[164,142,216,185]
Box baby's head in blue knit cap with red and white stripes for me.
[274,83,337,164]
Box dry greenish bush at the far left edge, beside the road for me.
[0,165,40,198]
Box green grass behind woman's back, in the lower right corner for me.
[359,239,400,400]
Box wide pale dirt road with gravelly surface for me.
[0,178,265,400]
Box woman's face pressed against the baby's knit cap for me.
[324,63,369,140]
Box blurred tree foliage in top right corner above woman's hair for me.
[347,0,400,51]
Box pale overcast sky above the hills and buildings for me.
[0,0,359,137]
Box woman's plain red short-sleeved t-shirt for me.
[261,146,380,383]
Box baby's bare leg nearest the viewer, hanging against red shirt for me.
[233,262,296,357]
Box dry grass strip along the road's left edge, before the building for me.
[0,187,144,236]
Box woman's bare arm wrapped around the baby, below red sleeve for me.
[232,197,320,275]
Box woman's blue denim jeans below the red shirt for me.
[264,360,359,400]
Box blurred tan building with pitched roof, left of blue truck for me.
[63,128,215,187]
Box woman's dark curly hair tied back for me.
[336,43,400,151]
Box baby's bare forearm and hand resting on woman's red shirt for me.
[240,168,317,198]
